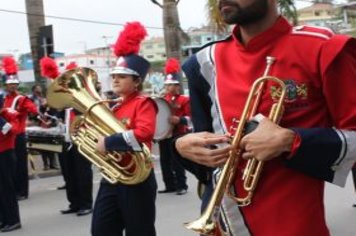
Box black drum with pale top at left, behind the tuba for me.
[26,126,64,153]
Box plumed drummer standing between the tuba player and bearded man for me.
[158,58,190,195]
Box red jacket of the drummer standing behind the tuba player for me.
[163,94,191,136]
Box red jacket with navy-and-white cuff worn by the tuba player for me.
[105,92,157,151]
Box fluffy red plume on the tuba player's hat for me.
[114,22,147,57]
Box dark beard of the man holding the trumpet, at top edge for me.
[219,0,269,25]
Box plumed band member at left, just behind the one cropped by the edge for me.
[3,57,39,200]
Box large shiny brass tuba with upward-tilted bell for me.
[47,67,152,185]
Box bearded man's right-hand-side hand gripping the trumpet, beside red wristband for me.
[240,118,295,161]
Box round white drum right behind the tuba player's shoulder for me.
[153,97,173,141]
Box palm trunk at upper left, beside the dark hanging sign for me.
[26,0,46,91]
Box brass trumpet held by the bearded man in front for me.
[185,57,287,235]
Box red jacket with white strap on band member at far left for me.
[4,93,38,134]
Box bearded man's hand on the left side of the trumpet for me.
[175,132,231,167]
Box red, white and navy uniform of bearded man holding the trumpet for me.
[183,17,356,236]
